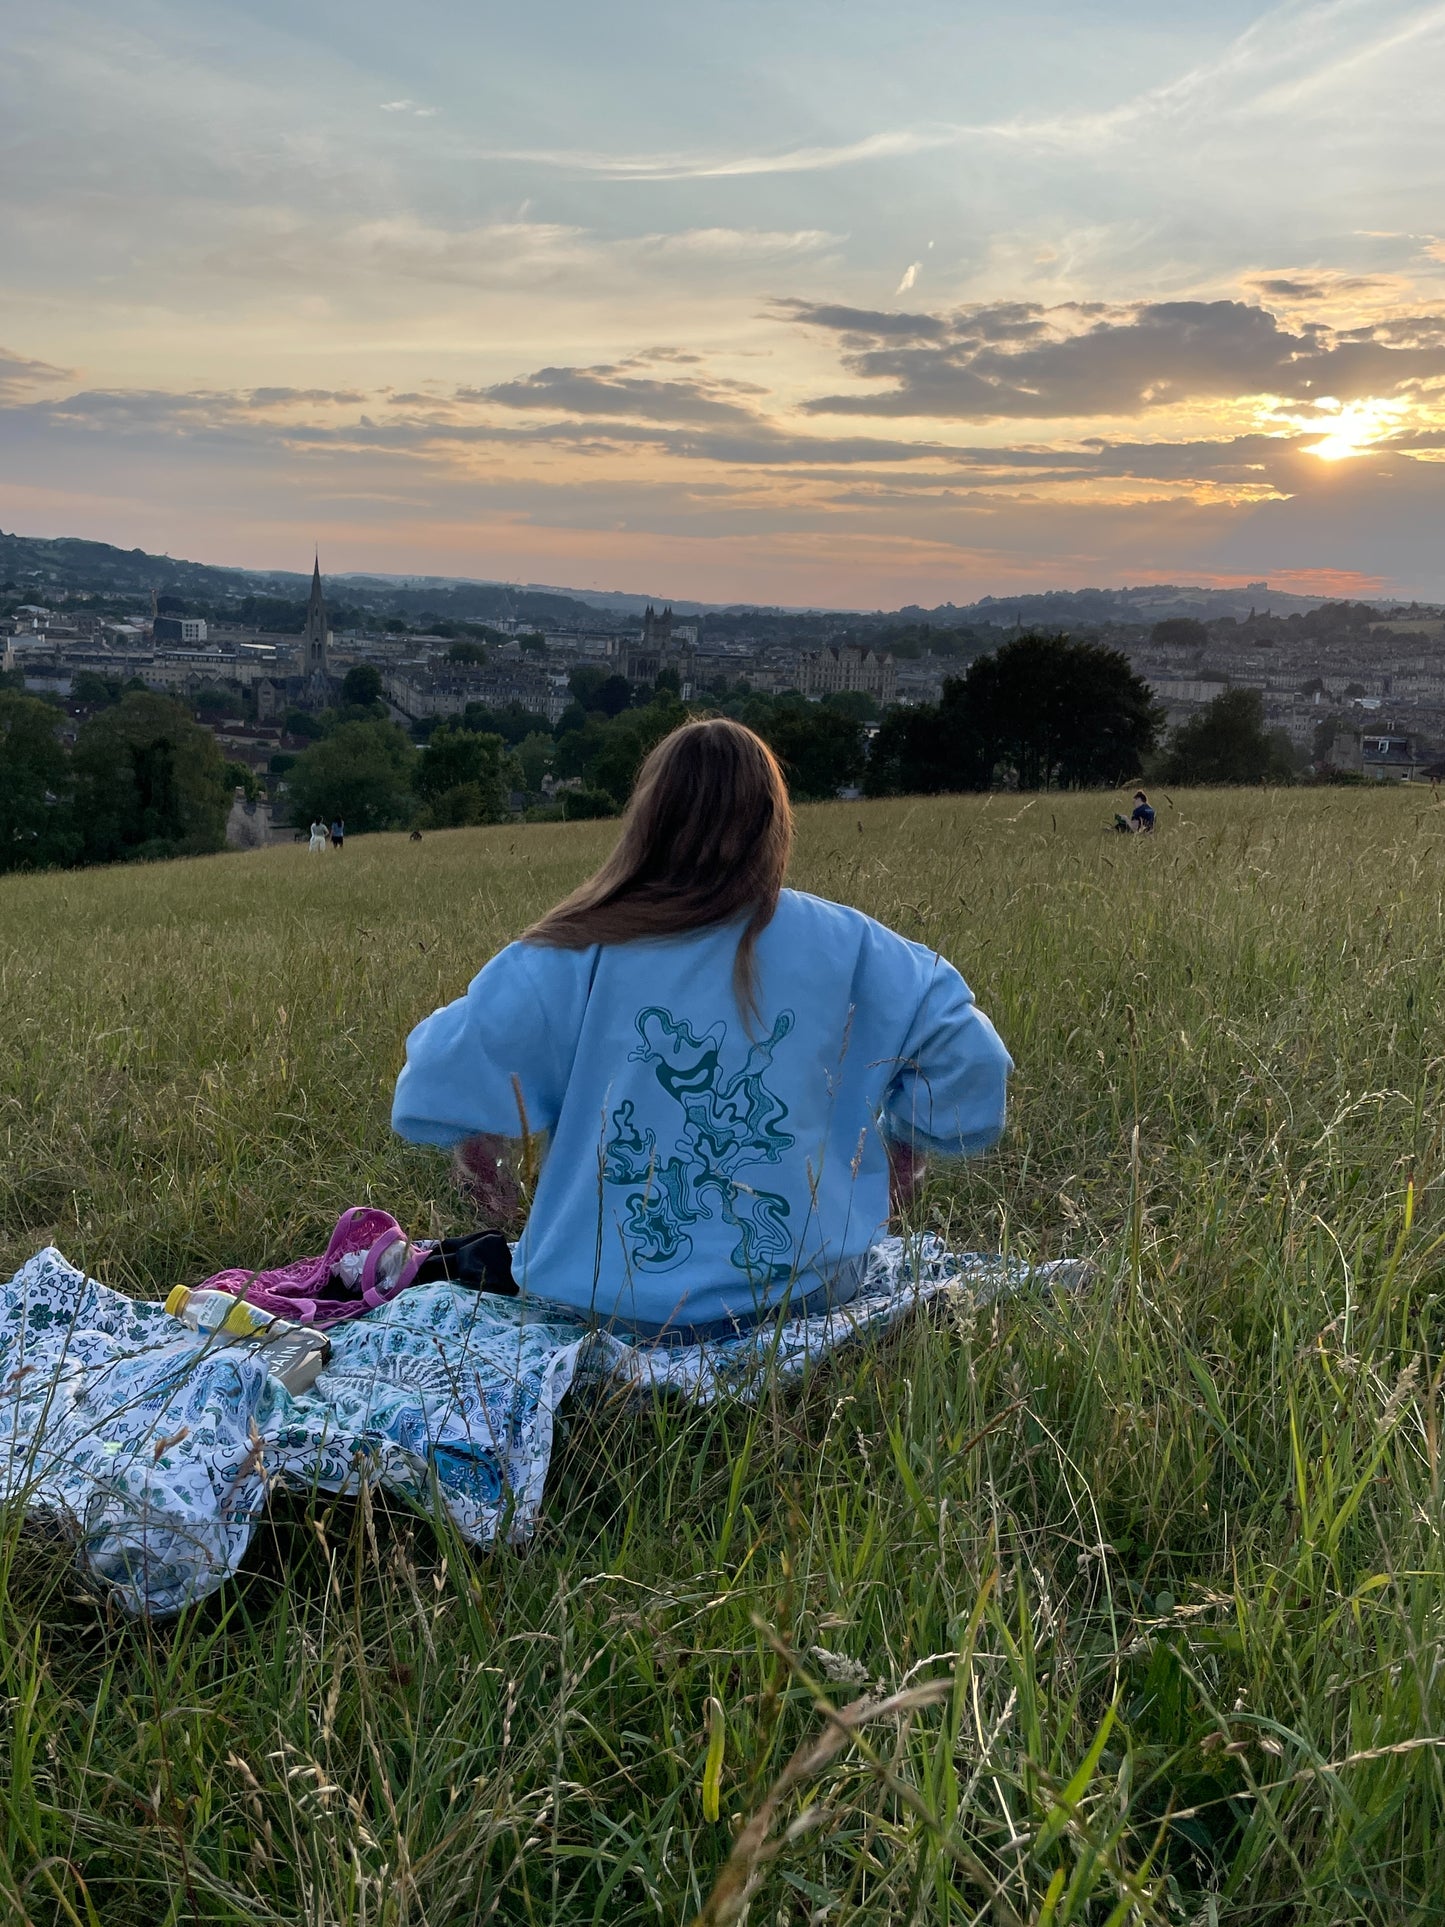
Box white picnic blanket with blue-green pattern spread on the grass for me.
[0,1237,1085,1615]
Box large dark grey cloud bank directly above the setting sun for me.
[782,301,1445,422]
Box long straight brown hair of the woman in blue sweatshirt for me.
[522,717,792,1016]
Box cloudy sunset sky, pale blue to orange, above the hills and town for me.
[0,0,1445,607]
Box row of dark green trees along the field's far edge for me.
[0,636,1295,869]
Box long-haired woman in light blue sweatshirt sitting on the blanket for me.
[391,719,1012,1341]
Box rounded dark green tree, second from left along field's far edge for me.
[71,690,231,863]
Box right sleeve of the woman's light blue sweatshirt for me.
[882,946,1013,1156]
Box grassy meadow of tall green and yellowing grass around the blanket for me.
[0,790,1445,1927]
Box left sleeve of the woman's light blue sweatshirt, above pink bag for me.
[391,944,578,1145]
